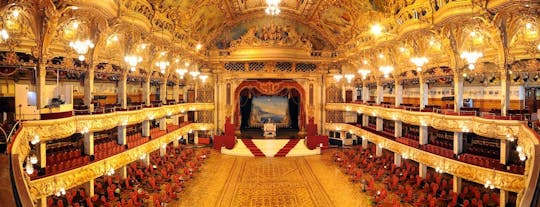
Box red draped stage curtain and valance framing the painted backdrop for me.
[234,79,307,131]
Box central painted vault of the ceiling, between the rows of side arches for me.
[151,0,388,49]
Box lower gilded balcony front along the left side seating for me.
[24,123,214,199]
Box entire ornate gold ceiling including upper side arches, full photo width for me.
[0,0,540,81]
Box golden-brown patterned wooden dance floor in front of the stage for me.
[168,153,370,207]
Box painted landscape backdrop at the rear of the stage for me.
[249,96,291,128]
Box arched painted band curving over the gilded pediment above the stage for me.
[213,18,333,50]
